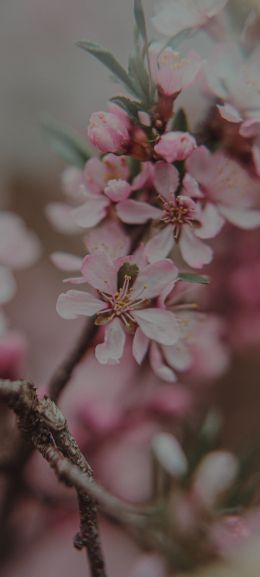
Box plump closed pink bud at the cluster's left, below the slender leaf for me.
[88,112,129,152]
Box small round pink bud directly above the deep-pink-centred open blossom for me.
[154,131,197,162]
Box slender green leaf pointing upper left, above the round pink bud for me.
[76,40,136,94]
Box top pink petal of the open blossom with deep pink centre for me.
[154,161,180,201]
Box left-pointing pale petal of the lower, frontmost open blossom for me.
[56,290,104,319]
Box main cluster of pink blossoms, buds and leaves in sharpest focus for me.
[48,1,260,381]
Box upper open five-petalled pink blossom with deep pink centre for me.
[119,162,214,268]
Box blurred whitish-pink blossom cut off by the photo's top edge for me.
[153,0,228,36]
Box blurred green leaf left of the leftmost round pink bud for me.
[42,118,91,168]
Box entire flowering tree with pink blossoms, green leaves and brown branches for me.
[0,0,260,577]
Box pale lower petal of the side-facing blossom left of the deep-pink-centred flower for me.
[72,196,110,228]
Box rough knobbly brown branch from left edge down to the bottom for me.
[0,381,105,577]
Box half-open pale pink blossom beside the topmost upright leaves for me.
[150,48,202,96]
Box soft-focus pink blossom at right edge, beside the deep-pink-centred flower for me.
[184,146,260,230]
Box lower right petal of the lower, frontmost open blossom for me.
[132,308,180,345]
